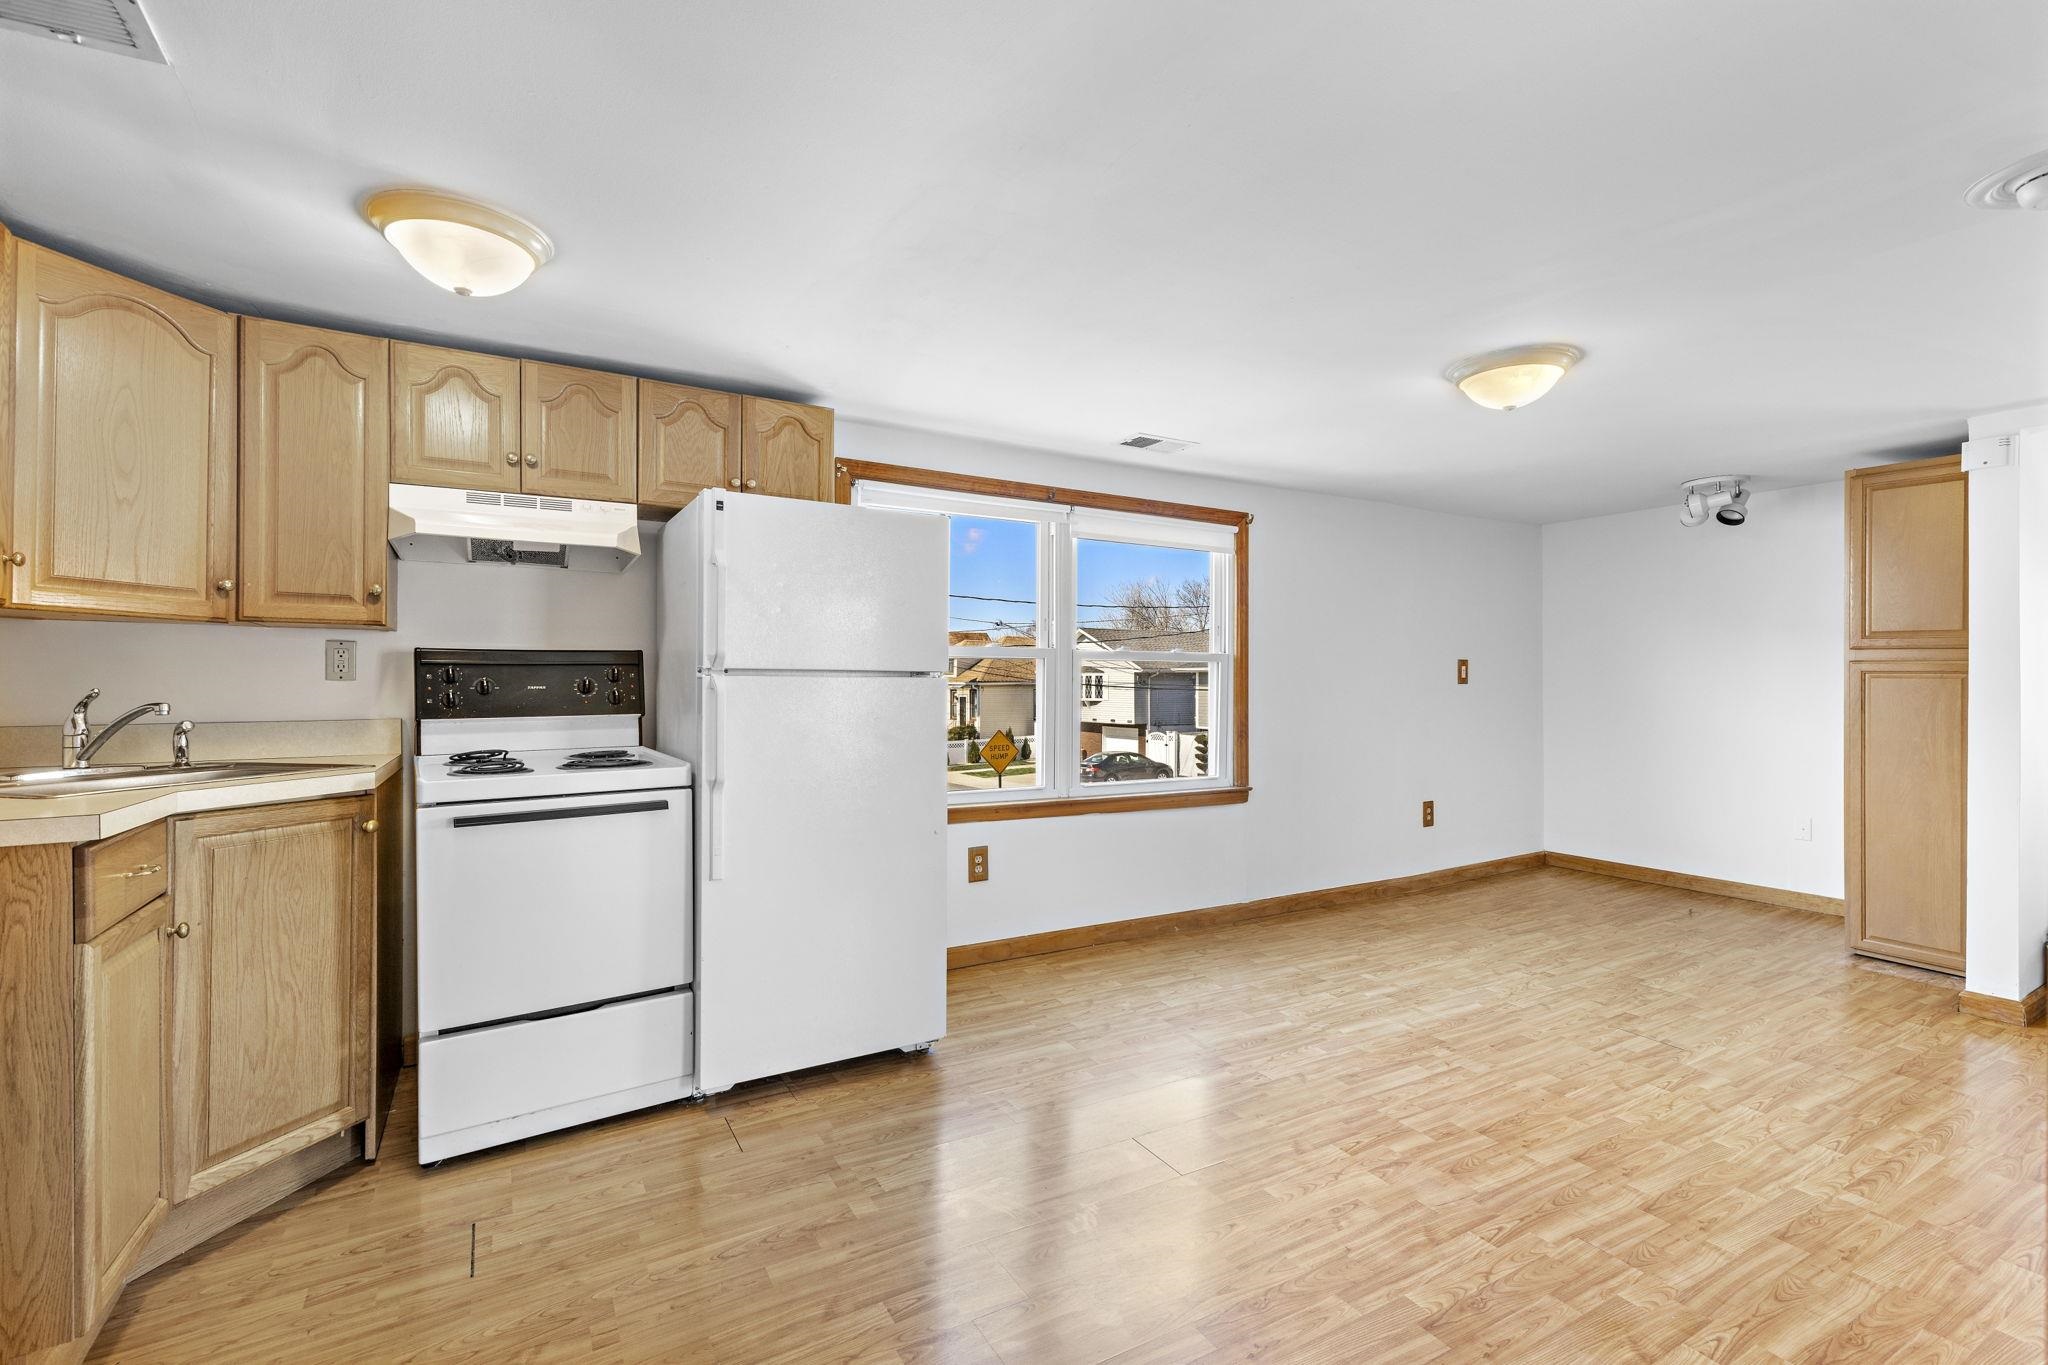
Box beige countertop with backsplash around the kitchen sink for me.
[0,720,403,845]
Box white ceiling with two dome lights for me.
[0,0,2048,520]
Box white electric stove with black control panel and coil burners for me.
[414,649,694,1162]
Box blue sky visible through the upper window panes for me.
[946,516,1208,634]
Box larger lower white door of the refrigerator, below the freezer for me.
[696,673,946,1091]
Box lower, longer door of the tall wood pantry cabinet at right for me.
[1845,659,1970,974]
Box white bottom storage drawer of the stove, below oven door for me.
[420,990,692,1142]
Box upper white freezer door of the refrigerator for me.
[698,493,946,679]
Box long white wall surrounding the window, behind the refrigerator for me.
[838,422,1542,943]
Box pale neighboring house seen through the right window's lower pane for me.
[1077,626,1208,776]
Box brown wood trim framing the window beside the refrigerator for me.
[831,460,1251,825]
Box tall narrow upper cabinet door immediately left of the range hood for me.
[238,317,391,626]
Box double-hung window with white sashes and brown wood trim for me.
[842,463,1251,821]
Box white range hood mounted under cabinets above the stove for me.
[391,483,639,573]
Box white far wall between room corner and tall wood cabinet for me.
[1542,483,1845,896]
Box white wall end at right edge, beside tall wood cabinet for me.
[1966,407,2048,1001]
